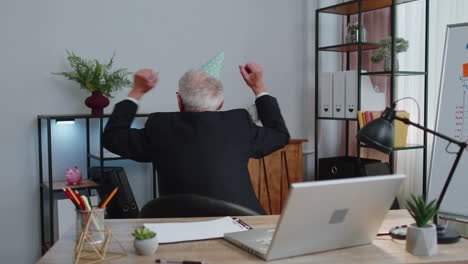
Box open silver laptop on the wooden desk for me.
[224,175,405,260]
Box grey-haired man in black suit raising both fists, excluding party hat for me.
[103,62,289,213]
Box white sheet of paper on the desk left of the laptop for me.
[144,216,248,243]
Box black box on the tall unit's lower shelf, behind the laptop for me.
[316,156,380,180]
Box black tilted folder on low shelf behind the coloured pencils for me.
[88,167,140,219]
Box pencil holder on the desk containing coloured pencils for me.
[76,208,105,244]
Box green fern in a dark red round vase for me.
[52,50,131,115]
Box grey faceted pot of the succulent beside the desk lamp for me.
[406,224,437,256]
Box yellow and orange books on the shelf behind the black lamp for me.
[358,111,409,148]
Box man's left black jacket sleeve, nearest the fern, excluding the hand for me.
[103,100,151,162]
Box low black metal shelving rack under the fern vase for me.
[37,114,156,253]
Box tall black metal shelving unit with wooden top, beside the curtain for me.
[314,0,429,195]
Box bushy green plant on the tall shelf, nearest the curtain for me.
[371,37,409,71]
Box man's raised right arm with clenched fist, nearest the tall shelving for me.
[239,62,289,158]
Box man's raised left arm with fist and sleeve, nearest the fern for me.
[103,69,159,162]
